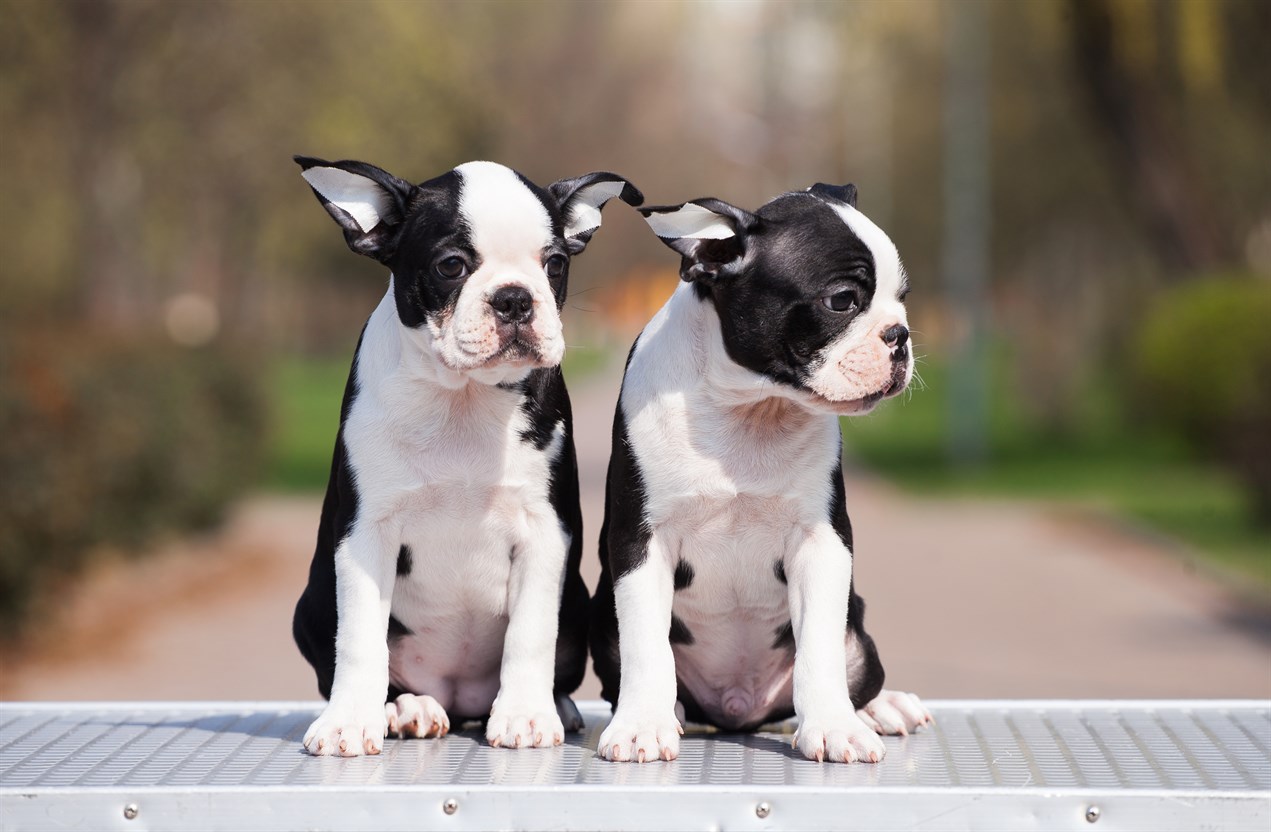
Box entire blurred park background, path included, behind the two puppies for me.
[0,0,1271,699]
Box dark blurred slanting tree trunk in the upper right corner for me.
[1069,0,1235,277]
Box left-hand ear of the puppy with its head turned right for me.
[639,198,763,283]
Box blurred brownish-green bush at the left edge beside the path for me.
[0,329,266,638]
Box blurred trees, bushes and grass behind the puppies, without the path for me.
[0,0,1271,632]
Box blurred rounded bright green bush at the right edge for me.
[1134,274,1271,525]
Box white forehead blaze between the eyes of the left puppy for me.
[455,161,552,260]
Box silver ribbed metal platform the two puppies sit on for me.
[0,701,1271,832]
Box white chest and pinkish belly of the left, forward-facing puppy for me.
[344,293,563,715]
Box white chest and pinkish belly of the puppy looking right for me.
[623,285,840,724]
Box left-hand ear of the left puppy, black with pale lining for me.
[295,156,414,263]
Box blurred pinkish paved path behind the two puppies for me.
[0,368,1271,700]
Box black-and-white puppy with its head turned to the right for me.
[591,184,930,762]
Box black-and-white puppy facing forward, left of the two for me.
[292,158,642,756]
